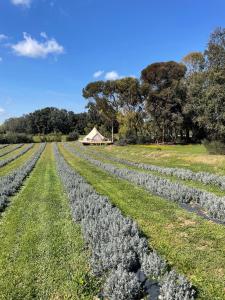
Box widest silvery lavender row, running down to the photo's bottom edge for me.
[54,145,195,300]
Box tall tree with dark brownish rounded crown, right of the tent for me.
[141,61,186,142]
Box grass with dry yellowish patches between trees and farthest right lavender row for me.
[88,145,225,175]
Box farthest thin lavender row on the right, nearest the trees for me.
[77,144,225,190]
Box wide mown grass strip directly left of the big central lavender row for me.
[0,145,96,300]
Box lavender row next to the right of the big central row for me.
[64,144,225,223]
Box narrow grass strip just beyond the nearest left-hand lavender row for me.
[0,144,40,176]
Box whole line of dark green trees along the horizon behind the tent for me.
[1,28,225,148]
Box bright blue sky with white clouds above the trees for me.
[0,0,225,122]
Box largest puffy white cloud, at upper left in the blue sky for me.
[11,32,64,58]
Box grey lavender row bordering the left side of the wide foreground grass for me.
[0,144,45,212]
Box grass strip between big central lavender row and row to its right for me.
[60,145,225,300]
